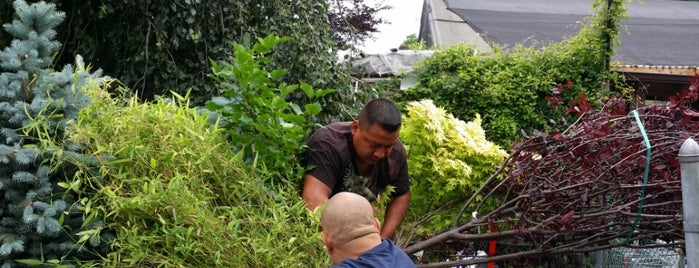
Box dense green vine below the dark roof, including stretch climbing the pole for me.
[399,1,624,149]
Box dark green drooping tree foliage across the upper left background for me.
[0,0,386,122]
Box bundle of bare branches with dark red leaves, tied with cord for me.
[406,75,699,266]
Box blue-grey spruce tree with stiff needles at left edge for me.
[0,0,110,268]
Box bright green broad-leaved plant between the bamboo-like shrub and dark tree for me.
[206,35,333,183]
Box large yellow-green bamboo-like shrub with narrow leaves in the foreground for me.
[68,87,328,267]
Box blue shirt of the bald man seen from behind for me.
[331,239,417,268]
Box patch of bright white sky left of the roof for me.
[352,0,424,54]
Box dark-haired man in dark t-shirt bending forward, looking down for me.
[302,99,410,239]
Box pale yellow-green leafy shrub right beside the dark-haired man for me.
[398,100,507,243]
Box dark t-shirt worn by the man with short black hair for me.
[303,122,410,201]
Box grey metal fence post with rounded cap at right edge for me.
[679,138,699,268]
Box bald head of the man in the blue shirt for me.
[320,192,379,246]
